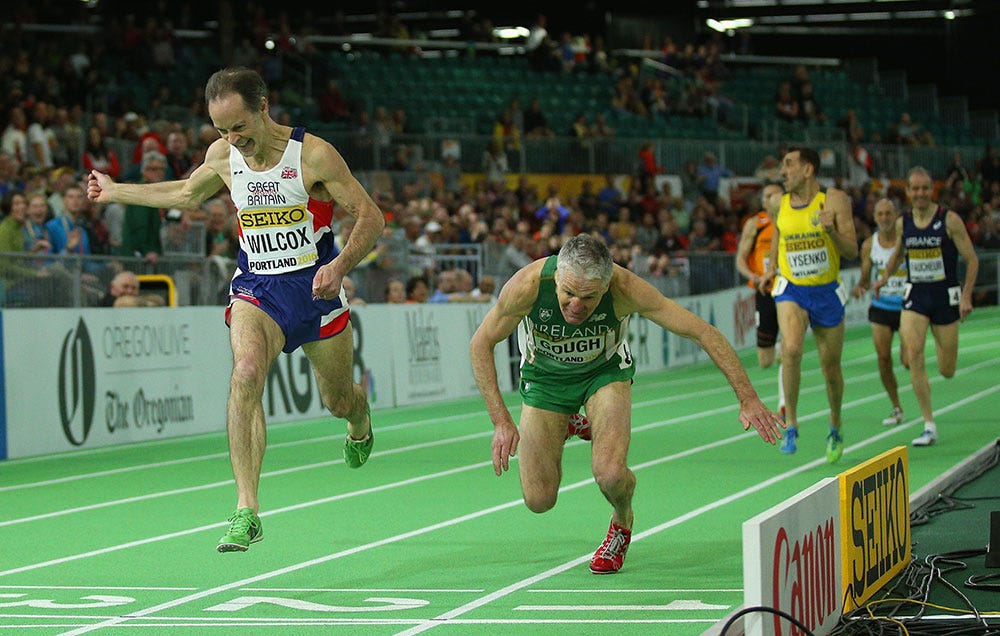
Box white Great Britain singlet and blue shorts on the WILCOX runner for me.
[226,128,350,353]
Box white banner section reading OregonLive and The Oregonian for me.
[3,307,232,457]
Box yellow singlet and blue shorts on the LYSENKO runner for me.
[771,189,847,327]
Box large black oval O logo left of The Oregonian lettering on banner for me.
[58,318,97,446]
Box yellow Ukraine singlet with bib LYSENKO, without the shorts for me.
[778,190,840,286]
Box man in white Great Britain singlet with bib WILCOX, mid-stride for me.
[88,68,385,552]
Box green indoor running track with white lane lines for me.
[0,308,1000,636]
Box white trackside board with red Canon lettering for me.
[743,477,843,636]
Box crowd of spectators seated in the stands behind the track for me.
[0,0,1000,302]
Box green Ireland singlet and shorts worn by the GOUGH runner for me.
[517,256,635,413]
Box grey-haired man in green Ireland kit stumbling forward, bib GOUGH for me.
[470,234,783,574]
